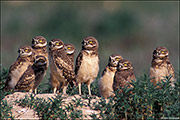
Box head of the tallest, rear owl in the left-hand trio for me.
[32,36,47,48]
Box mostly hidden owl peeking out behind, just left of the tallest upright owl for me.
[64,44,75,63]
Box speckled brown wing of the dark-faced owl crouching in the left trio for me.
[15,65,36,90]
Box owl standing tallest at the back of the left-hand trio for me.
[32,36,49,70]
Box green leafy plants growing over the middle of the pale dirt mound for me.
[16,95,82,119]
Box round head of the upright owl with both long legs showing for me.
[82,36,99,50]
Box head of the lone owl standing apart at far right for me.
[153,46,169,58]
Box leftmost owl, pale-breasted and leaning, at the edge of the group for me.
[4,45,34,90]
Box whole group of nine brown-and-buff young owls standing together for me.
[5,36,174,98]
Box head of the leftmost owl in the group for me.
[18,45,33,57]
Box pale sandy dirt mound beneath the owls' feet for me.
[4,92,100,119]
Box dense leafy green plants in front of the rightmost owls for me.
[91,74,180,119]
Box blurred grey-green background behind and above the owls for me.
[1,1,179,76]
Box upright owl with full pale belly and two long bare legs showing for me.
[75,36,99,95]
